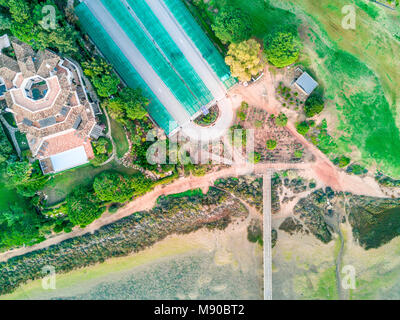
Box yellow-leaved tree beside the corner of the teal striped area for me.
[225,39,264,81]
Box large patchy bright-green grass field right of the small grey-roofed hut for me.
[268,0,400,177]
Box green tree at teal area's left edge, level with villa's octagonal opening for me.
[82,57,120,97]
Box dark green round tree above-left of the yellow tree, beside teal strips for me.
[211,6,252,43]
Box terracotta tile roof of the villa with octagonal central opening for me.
[4,40,96,173]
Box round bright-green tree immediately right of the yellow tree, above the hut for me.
[264,28,300,68]
